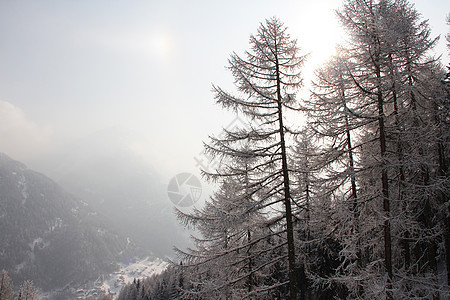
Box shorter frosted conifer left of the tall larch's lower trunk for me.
[178,151,278,299]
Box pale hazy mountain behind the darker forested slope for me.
[35,128,188,257]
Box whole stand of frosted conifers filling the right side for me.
[119,0,450,299]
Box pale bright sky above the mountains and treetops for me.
[0,0,450,178]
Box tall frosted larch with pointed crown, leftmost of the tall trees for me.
[207,18,304,299]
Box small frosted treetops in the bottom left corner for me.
[0,270,38,300]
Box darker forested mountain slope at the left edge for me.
[0,153,137,291]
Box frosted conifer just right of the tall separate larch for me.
[303,53,372,296]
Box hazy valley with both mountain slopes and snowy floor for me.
[0,130,187,299]
